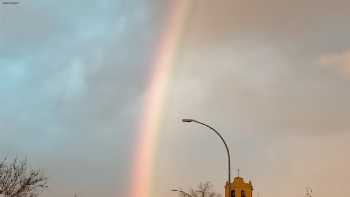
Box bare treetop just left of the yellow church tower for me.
[172,182,221,197]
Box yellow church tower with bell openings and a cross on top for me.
[225,175,253,197]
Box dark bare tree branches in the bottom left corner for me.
[0,158,47,197]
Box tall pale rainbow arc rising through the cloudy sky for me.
[129,0,192,197]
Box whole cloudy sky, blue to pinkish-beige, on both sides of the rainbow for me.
[0,0,350,197]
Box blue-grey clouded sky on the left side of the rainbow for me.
[0,0,169,196]
